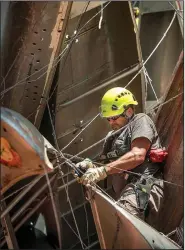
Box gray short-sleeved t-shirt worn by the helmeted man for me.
[103,113,161,193]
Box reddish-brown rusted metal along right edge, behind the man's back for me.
[156,52,184,233]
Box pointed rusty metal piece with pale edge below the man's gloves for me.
[88,188,179,249]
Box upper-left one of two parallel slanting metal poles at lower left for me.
[1,175,43,219]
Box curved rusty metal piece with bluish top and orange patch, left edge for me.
[0,108,55,193]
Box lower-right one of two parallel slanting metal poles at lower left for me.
[11,175,56,223]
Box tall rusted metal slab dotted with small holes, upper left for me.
[1,1,71,126]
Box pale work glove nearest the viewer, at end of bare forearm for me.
[78,167,107,185]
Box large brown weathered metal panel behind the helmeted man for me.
[55,2,142,160]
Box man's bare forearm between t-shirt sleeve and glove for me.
[105,151,145,175]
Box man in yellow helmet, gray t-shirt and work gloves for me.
[74,87,167,227]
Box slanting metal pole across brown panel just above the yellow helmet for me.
[59,64,140,108]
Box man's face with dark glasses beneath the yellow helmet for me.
[107,108,134,130]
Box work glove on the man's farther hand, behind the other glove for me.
[73,158,96,178]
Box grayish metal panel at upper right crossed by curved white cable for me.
[140,11,183,101]
